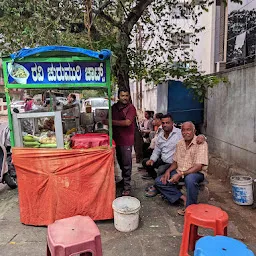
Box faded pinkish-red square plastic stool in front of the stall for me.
[47,215,102,256]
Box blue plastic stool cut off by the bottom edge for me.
[194,236,254,256]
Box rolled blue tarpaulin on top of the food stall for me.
[10,45,111,61]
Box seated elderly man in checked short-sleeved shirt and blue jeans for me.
[155,122,208,215]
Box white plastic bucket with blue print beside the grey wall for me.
[230,176,253,205]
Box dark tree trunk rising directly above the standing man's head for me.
[114,31,131,92]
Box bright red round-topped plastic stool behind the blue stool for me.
[179,204,228,256]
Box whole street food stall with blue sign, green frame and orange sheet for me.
[3,46,115,225]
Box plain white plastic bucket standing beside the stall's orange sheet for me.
[112,196,140,232]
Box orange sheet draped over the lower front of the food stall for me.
[13,147,115,226]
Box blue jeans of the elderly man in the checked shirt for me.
[155,170,204,207]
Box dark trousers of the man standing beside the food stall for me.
[116,146,132,190]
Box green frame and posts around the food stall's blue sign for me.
[2,52,113,147]
